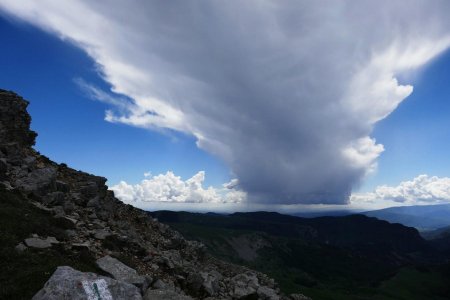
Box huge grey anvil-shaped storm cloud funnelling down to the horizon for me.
[0,0,450,204]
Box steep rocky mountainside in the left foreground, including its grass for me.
[0,90,307,300]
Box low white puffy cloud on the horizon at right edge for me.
[351,175,450,206]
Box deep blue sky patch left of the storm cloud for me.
[0,17,230,185]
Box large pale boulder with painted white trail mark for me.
[32,266,142,300]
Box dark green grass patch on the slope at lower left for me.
[0,188,99,299]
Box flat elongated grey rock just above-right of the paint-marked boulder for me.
[97,255,146,287]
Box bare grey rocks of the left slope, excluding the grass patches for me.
[0,90,306,299]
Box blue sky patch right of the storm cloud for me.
[361,51,450,190]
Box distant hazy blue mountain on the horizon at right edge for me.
[362,204,450,231]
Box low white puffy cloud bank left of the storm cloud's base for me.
[110,171,246,205]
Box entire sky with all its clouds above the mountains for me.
[0,0,450,212]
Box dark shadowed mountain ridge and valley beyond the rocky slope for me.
[149,211,450,300]
